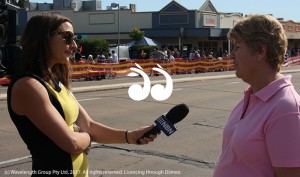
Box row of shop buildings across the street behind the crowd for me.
[9,0,300,56]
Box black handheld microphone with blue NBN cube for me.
[136,103,189,144]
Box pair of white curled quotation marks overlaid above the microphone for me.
[127,63,173,101]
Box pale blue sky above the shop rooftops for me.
[30,0,300,22]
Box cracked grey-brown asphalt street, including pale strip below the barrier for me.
[0,66,300,177]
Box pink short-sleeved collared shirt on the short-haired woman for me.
[214,76,300,177]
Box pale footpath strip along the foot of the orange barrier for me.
[0,65,300,101]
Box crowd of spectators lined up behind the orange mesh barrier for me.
[71,44,300,80]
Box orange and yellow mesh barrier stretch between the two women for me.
[71,58,234,78]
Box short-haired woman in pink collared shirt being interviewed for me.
[214,15,300,177]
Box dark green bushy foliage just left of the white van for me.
[77,39,109,58]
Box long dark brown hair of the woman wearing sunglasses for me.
[21,13,72,88]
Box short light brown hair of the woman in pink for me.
[228,14,288,71]
